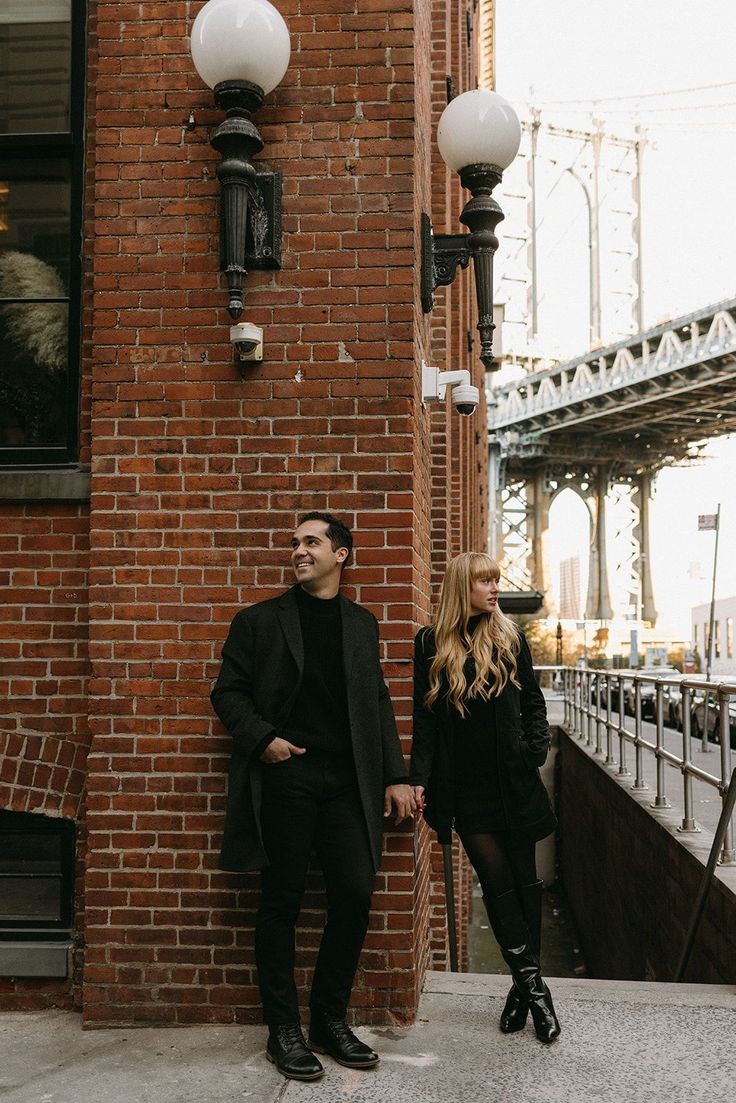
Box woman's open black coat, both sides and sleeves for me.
[410,628,555,843]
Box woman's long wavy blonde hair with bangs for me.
[425,552,520,716]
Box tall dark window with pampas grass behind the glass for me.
[0,0,85,464]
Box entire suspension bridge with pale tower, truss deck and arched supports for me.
[488,113,736,625]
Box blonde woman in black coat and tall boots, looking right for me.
[412,552,559,1042]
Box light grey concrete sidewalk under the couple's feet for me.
[0,973,736,1103]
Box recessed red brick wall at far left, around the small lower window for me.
[0,0,97,1009]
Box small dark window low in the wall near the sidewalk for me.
[0,812,74,940]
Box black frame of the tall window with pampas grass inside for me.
[0,0,87,471]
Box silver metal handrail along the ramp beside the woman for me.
[536,666,736,865]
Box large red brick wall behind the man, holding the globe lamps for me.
[0,0,494,1026]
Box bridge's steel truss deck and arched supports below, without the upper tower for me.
[488,299,736,624]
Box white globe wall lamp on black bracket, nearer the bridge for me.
[422,88,521,371]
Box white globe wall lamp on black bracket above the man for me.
[191,0,291,320]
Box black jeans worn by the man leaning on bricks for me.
[256,750,374,1027]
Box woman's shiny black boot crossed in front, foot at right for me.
[483,890,559,1043]
